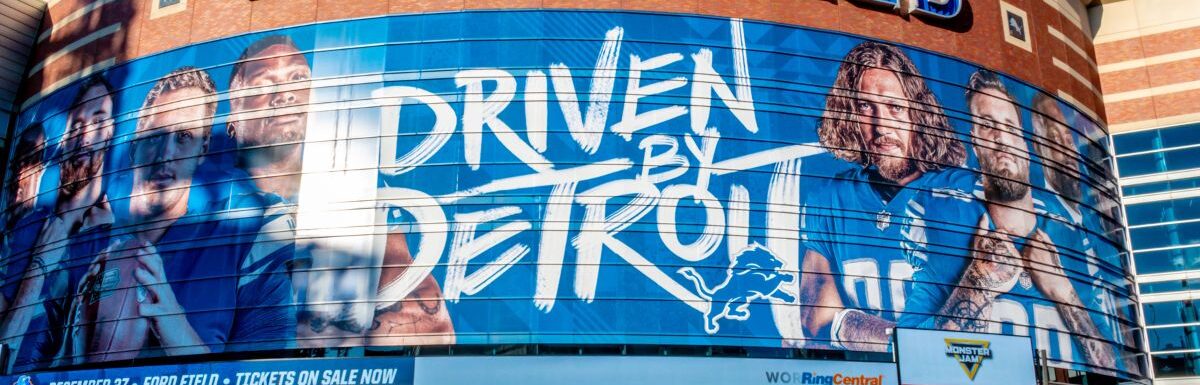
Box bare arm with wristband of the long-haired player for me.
[799,249,895,351]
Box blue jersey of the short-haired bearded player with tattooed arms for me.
[899,182,1116,371]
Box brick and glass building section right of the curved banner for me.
[1090,0,1200,385]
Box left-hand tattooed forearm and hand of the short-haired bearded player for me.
[934,215,1021,331]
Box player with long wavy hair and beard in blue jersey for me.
[785,42,971,350]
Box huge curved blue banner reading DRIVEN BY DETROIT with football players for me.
[0,11,1140,375]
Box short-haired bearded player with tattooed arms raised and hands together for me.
[901,71,1116,368]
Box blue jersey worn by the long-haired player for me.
[800,168,972,320]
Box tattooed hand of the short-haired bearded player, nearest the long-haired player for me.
[965,213,1021,293]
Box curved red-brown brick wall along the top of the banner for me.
[23,0,1104,116]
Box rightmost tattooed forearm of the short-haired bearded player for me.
[1025,230,1116,368]
